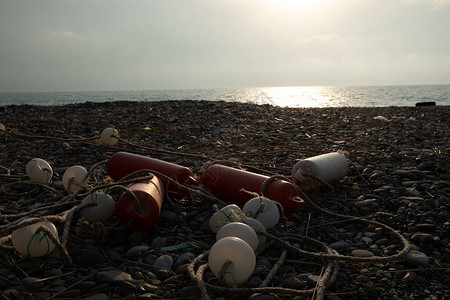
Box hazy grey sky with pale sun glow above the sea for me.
[0,0,450,92]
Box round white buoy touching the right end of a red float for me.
[242,197,280,229]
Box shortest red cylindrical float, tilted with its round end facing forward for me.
[116,176,164,231]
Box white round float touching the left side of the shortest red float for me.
[80,192,116,223]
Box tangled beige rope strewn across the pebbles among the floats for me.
[0,123,410,299]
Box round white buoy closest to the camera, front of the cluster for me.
[208,236,256,285]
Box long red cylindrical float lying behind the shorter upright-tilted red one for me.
[106,152,198,199]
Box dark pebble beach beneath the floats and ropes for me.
[0,100,450,300]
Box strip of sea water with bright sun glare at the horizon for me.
[0,85,450,107]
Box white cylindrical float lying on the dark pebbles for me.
[292,152,348,191]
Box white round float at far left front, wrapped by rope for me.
[11,218,58,257]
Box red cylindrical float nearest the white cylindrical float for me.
[200,164,305,217]
